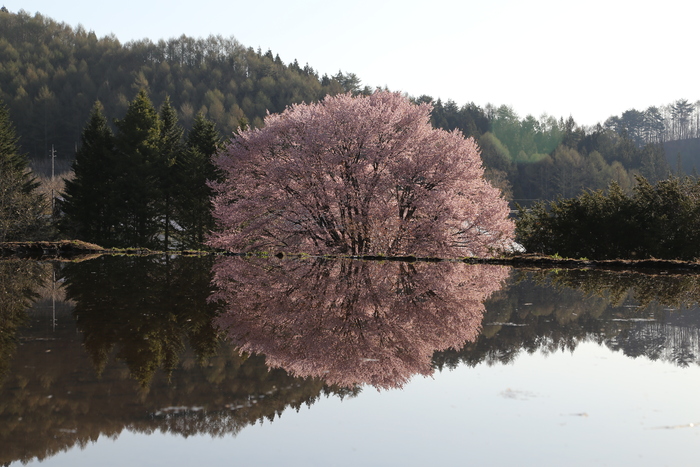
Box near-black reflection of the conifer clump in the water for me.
[65,257,217,387]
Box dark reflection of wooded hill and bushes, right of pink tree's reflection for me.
[433,270,700,368]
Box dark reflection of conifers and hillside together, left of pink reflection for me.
[0,257,353,465]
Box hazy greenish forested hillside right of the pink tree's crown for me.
[430,101,669,205]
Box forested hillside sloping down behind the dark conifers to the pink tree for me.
[0,11,358,170]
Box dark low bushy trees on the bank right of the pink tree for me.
[517,177,700,261]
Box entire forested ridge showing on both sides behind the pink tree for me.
[0,7,700,205]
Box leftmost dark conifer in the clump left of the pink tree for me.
[61,101,119,246]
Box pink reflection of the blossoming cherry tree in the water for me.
[212,258,509,388]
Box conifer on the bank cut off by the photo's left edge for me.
[0,102,48,242]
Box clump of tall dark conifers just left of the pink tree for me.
[60,91,220,249]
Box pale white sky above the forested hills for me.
[0,0,700,125]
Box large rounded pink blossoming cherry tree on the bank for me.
[209,91,513,256]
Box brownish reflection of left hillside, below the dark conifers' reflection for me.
[0,322,334,465]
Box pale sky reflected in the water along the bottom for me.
[26,343,700,467]
